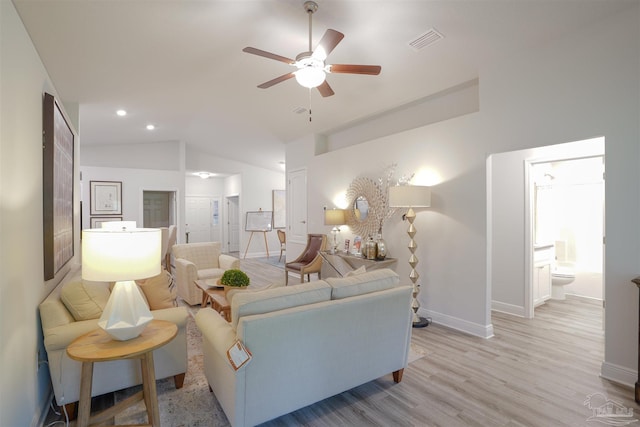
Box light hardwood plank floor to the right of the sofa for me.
[241,260,640,427]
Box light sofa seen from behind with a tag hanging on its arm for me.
[196,269,412,427]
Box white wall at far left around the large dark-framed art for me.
[0,1,80,426]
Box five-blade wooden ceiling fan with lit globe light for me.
[242,1,382,97]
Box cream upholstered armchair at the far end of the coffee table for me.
[172,242,240,305]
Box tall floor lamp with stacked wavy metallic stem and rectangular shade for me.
[389,185,431,328]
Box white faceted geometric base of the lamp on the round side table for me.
[98,281,153,341]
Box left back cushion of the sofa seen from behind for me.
[231,280,331,329]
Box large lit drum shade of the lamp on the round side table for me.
[82,228,162,282]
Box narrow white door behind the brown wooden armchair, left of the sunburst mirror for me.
[287,169,307,244]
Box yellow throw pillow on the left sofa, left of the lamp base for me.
[60,277,111,321]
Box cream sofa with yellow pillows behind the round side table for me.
[39,266,189,410]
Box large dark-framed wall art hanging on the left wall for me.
[42,93,74,280]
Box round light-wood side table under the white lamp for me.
[67,320,178,427]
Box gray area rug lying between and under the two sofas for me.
[115,306,426,427]
